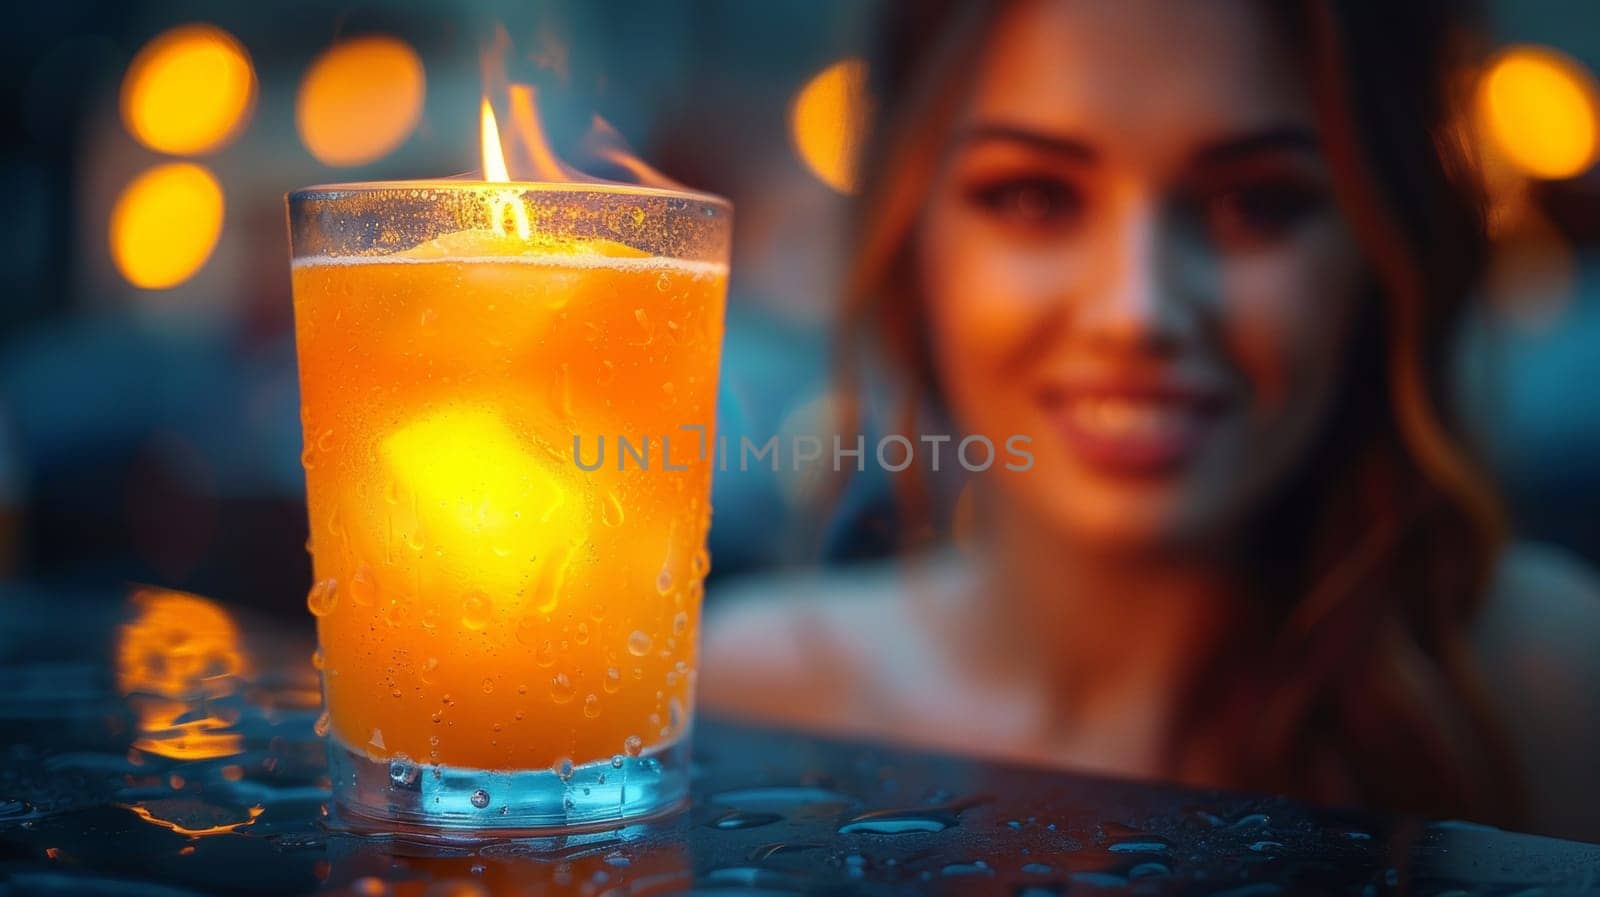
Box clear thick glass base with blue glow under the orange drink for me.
[328,737,690,838]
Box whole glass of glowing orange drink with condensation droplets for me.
[288,181,731,830]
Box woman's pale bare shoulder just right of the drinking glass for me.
[699,553,960,731]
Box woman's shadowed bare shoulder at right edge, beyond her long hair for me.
[1475,544,1600,841]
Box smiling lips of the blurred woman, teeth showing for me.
[1040,379,1227,476]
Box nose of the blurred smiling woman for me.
[1074,200,1190,350]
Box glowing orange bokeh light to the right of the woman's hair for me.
[1478,46,1600,179]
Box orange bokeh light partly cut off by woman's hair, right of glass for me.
[789,59,869,193]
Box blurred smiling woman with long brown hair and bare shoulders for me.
[701,0,1600,838]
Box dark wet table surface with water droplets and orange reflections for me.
[0,587,1600,897]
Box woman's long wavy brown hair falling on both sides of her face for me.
[838,0,1518,822]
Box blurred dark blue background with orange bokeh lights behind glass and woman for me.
[0,0,1600,628]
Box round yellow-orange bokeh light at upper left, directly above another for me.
[122,26,256,155]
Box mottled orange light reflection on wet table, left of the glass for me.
[117,590,248,759]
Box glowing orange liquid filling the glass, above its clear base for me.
[294,235,726,769]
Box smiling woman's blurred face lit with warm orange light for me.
[915,0,1365,550]
